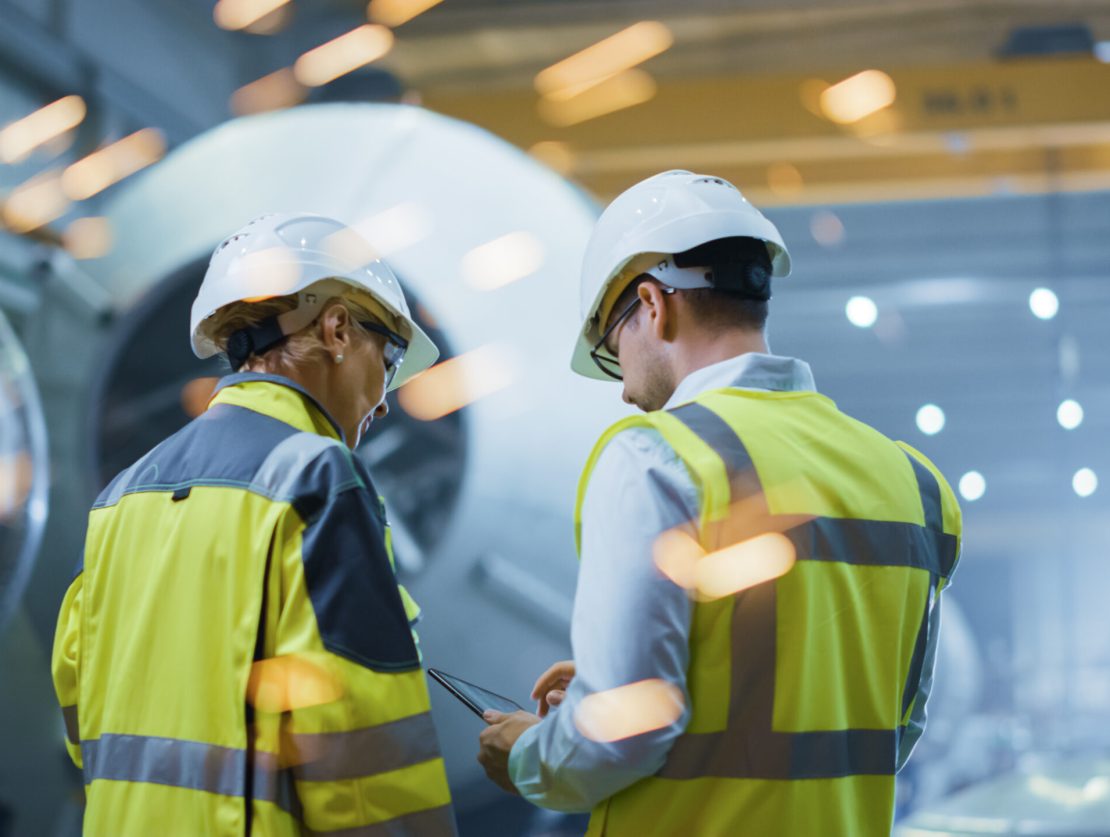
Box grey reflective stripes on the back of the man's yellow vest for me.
[658,402,956,779]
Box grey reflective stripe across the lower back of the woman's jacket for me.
[81,734,246,796]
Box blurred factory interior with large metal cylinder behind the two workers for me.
[0,0,1110,837]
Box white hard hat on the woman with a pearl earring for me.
[190,213,440,390]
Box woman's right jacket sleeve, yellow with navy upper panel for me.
[250,450,454,834]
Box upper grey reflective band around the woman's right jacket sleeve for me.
[289,712,440,781]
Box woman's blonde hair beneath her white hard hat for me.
[206,294,392,374]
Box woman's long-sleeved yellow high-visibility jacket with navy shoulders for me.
[53,374,455,837]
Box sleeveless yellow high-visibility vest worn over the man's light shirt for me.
[577,389,961,837]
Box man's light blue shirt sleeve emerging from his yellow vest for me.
[509,428,697,811]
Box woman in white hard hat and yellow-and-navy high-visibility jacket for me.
[53,214,455,837]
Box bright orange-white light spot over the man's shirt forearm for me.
[574,679,686,742]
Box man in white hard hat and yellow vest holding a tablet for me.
[480,171,960,837]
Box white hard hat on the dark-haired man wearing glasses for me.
[571,169,790,381]
